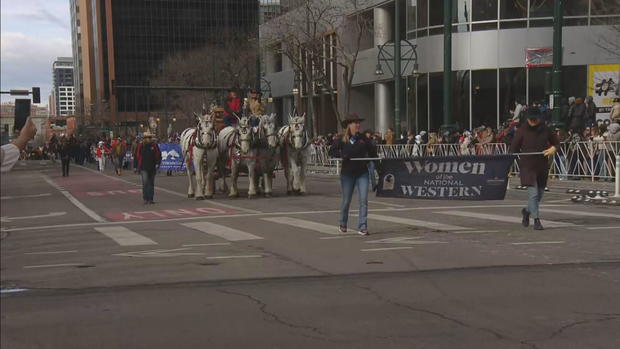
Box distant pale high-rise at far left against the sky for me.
[52,57,75,116]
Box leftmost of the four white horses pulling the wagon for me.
[181,111,219,200]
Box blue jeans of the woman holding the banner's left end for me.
[340,171,369,230]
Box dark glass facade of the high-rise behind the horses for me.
[109,0,260,111]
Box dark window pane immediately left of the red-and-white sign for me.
[499,68,525,121]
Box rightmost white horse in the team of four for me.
[278,114,311,194]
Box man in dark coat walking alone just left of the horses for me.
[137,132,161,205]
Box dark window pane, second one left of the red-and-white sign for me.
[471,69,497,127]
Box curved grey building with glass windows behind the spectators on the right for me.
[261,0,620,134]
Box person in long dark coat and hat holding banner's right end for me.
[510,108,560,230]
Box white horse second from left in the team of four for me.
[218,116,257,198]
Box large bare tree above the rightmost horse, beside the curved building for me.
[263,0,371,134]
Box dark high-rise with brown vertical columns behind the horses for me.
[71,0,259,135]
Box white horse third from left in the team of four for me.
[256,114,280,197]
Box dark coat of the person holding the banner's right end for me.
[510,122,560,188]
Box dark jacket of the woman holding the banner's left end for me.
[329,133,378,177]
